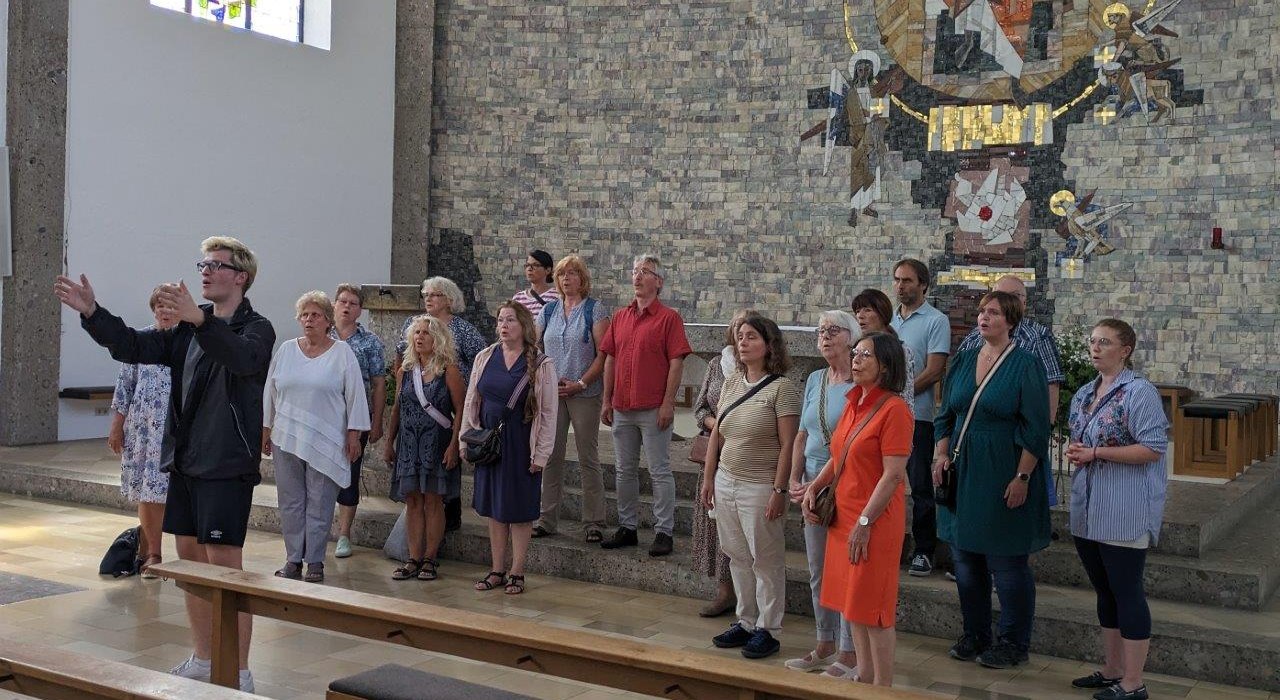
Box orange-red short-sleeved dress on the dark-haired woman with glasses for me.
[820,386,915,627]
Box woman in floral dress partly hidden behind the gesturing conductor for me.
[106,287,177,578]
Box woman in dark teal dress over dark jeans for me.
[933,292,1050,668]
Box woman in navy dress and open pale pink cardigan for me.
[462,301,559,595]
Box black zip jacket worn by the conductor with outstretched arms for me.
[81,298,275,484]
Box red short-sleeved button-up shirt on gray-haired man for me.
[600,299,694,411]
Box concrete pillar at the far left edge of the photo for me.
[0,0,68,445]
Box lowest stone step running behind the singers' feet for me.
[0,465,1280,691]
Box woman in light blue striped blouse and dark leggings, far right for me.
[1066,319,1169,700]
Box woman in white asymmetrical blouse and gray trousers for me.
[262,292,369,584]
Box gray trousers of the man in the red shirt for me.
[613,408,676,535]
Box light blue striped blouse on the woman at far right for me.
[1071,369,1169,545]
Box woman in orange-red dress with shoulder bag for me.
[804,333,915,686]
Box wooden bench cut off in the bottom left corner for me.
[0,639,257,700]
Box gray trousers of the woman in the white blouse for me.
[271,444,342,564]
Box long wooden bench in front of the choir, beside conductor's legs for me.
[151,561,932,700]
